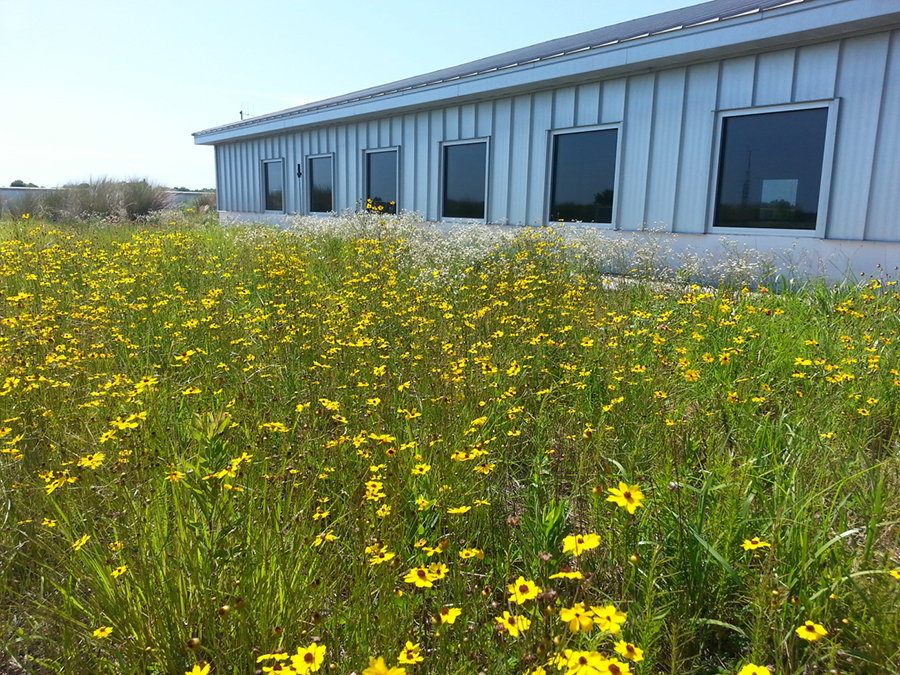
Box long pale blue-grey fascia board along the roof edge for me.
[194,0,900,145]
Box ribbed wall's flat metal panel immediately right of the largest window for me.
[825,33,896,239]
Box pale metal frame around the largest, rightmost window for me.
[704,98,840,239]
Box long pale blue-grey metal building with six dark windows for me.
[194,0,900,274]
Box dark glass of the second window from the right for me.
[550,129,619,223]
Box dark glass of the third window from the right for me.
[442,143,487,218]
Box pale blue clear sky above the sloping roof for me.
[0,0,696,189]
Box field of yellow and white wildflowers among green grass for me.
[0,214,900,675]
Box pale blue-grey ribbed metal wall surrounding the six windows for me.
[216,31,900,241]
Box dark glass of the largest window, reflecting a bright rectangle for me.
[713,108,828,230]
